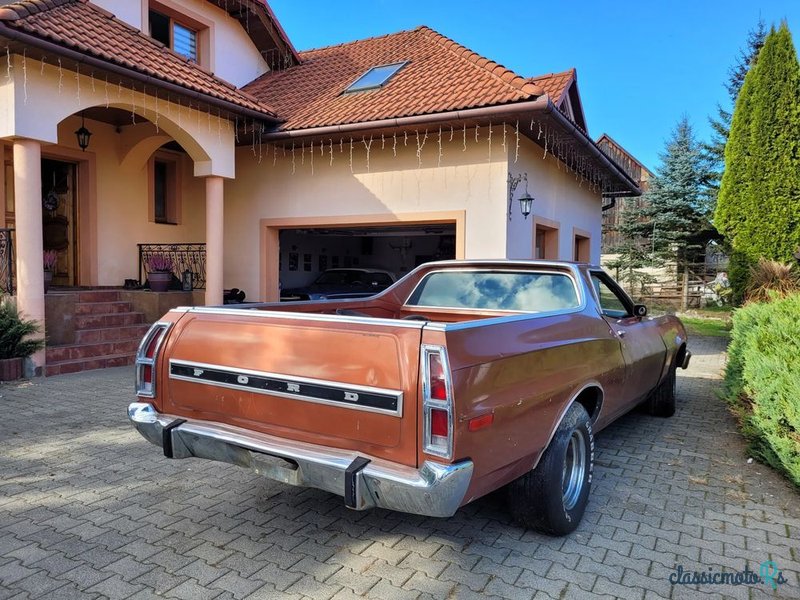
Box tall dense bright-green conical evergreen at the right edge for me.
[714,23,800,261]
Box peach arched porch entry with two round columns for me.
[0,56,235,367]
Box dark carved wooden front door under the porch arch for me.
[42,158,80,286]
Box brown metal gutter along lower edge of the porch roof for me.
[0,22,280,124]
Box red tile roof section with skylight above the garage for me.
[243,27,543,130]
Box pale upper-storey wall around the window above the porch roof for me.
[92,0,269,87]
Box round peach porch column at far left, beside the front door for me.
[14,139,45,368]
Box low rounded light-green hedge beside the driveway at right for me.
[724,294,800,487]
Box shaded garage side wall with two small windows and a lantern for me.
[507,132,602,264]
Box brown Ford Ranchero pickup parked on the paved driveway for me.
[128,260,691,535]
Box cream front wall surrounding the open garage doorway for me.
[225,127,508,299]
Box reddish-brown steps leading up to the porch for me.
[45,290,149,377]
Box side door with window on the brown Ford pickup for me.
[590,271,666,412]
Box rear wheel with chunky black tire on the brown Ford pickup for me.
[508,403,594,536]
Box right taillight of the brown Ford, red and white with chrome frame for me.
[421,345,453,459]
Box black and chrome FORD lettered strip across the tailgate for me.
[169,358,403,417]
